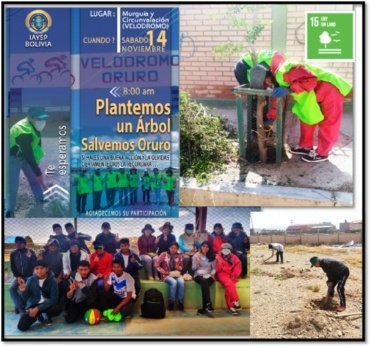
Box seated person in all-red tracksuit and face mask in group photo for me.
[216,243,242,316]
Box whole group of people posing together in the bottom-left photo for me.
[10,222,249,331]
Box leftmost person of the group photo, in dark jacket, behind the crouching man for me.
[9,236,37,314]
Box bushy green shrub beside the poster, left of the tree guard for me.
[180,92,237,182]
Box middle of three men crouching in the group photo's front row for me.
[64,260,97,323]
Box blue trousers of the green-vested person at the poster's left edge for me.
[6,156,44,212]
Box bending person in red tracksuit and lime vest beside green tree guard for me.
[251,61,352,162]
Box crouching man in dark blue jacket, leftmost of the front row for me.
[18,260,62,331]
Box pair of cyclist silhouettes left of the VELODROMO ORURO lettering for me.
[12,54,76,86]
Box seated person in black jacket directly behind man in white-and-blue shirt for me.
[114,238,143,296]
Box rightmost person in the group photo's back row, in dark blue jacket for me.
[227,222,250,278]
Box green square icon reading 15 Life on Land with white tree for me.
[306,12,355,62]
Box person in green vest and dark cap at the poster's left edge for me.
[5,107,49,218]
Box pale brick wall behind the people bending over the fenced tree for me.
[180,5,352,99]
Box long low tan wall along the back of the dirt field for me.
[250,232,362,245]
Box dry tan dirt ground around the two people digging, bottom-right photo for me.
[250,245,363,339]
